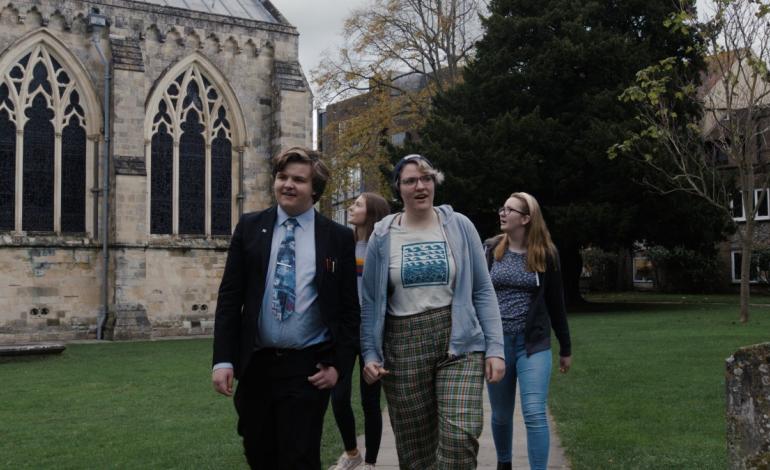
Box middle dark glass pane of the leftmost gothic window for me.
[21,92,55,232]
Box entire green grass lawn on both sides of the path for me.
[0,294,770,470]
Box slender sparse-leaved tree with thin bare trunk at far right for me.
[609,0,770,323]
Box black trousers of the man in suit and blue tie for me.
[234,348,329,470]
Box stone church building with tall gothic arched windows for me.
[0,0,312,344]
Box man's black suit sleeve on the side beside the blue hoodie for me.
[335,228,361,372]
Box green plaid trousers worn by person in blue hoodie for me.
[383,307,484,470]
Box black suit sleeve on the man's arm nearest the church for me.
[213,217,246,364]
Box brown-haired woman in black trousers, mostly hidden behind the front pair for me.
[332,193,390,470]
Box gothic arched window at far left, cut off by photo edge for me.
[0,44,87,233]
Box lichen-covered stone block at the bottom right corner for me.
[726,343,770,470]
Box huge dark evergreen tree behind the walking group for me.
[414,0,725,301]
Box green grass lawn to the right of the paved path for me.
[550,294,770,470]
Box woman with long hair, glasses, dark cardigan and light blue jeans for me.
[485,193,572,470]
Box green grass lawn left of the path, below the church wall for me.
[0,339,363,469]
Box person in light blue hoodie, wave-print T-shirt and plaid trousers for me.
[361,155,505,470]
